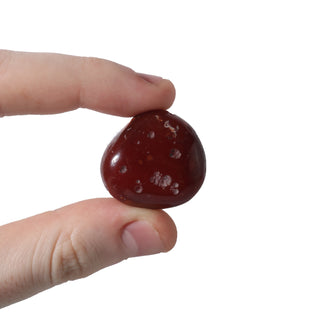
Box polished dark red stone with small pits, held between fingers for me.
[101,110,206,209]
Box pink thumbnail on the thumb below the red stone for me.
[122,221,164,257]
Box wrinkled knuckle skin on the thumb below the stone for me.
[50,232,89,285]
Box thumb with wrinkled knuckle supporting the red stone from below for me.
[0,199,177,308]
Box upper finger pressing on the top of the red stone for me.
[0,50,175,116]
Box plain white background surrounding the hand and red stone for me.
[0,0,320,320]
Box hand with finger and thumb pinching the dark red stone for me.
[0,50,176,308]
